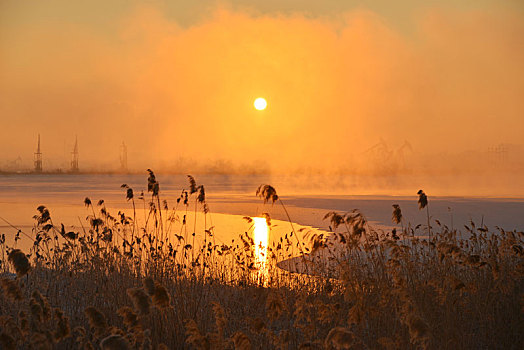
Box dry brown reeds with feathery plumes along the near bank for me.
[0,171,524,349]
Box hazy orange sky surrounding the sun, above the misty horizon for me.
[0,0,524,171]
